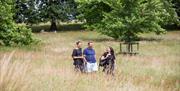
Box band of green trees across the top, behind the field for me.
[0,0,180,45]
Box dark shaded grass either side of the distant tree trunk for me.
[28,24,84,33]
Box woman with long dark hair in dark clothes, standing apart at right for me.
[99,46,116,75]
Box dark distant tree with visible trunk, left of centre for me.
[13,0,76,31]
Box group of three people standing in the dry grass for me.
[72,41,116,75]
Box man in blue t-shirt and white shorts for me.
[83,42,98,73]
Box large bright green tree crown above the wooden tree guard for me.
[78,0,177,41]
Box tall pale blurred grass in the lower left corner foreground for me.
[0,52,29,91]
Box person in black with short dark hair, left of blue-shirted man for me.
[72,41,84,72]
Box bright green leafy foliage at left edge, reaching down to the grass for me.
[0,0,37,46]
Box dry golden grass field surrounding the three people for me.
[0,31,180,91]
